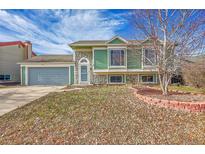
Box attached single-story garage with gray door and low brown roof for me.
[19,55,75,86]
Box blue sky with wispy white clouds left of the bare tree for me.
[0,10,133,54]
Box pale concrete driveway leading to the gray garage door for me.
[0,86,63,116]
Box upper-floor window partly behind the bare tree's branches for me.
[144,49,156,66]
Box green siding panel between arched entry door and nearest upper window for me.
[94,49,108,69]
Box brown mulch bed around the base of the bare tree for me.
[135,87,205,103]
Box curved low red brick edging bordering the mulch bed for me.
[130,87,205,112]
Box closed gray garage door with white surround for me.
[28,67,69,85]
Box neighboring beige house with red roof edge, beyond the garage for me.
[0,41,35,83]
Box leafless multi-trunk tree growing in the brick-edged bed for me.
[132,10,205,95]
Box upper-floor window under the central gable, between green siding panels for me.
[110,49,125,66]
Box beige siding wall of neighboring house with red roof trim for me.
[0,45,25,82]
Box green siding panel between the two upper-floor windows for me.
[127,49,142,69]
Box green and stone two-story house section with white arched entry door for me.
[69,36,158,84]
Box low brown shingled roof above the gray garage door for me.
[24,55,74,62]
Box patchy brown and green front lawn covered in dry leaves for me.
[0,86,205,144]
